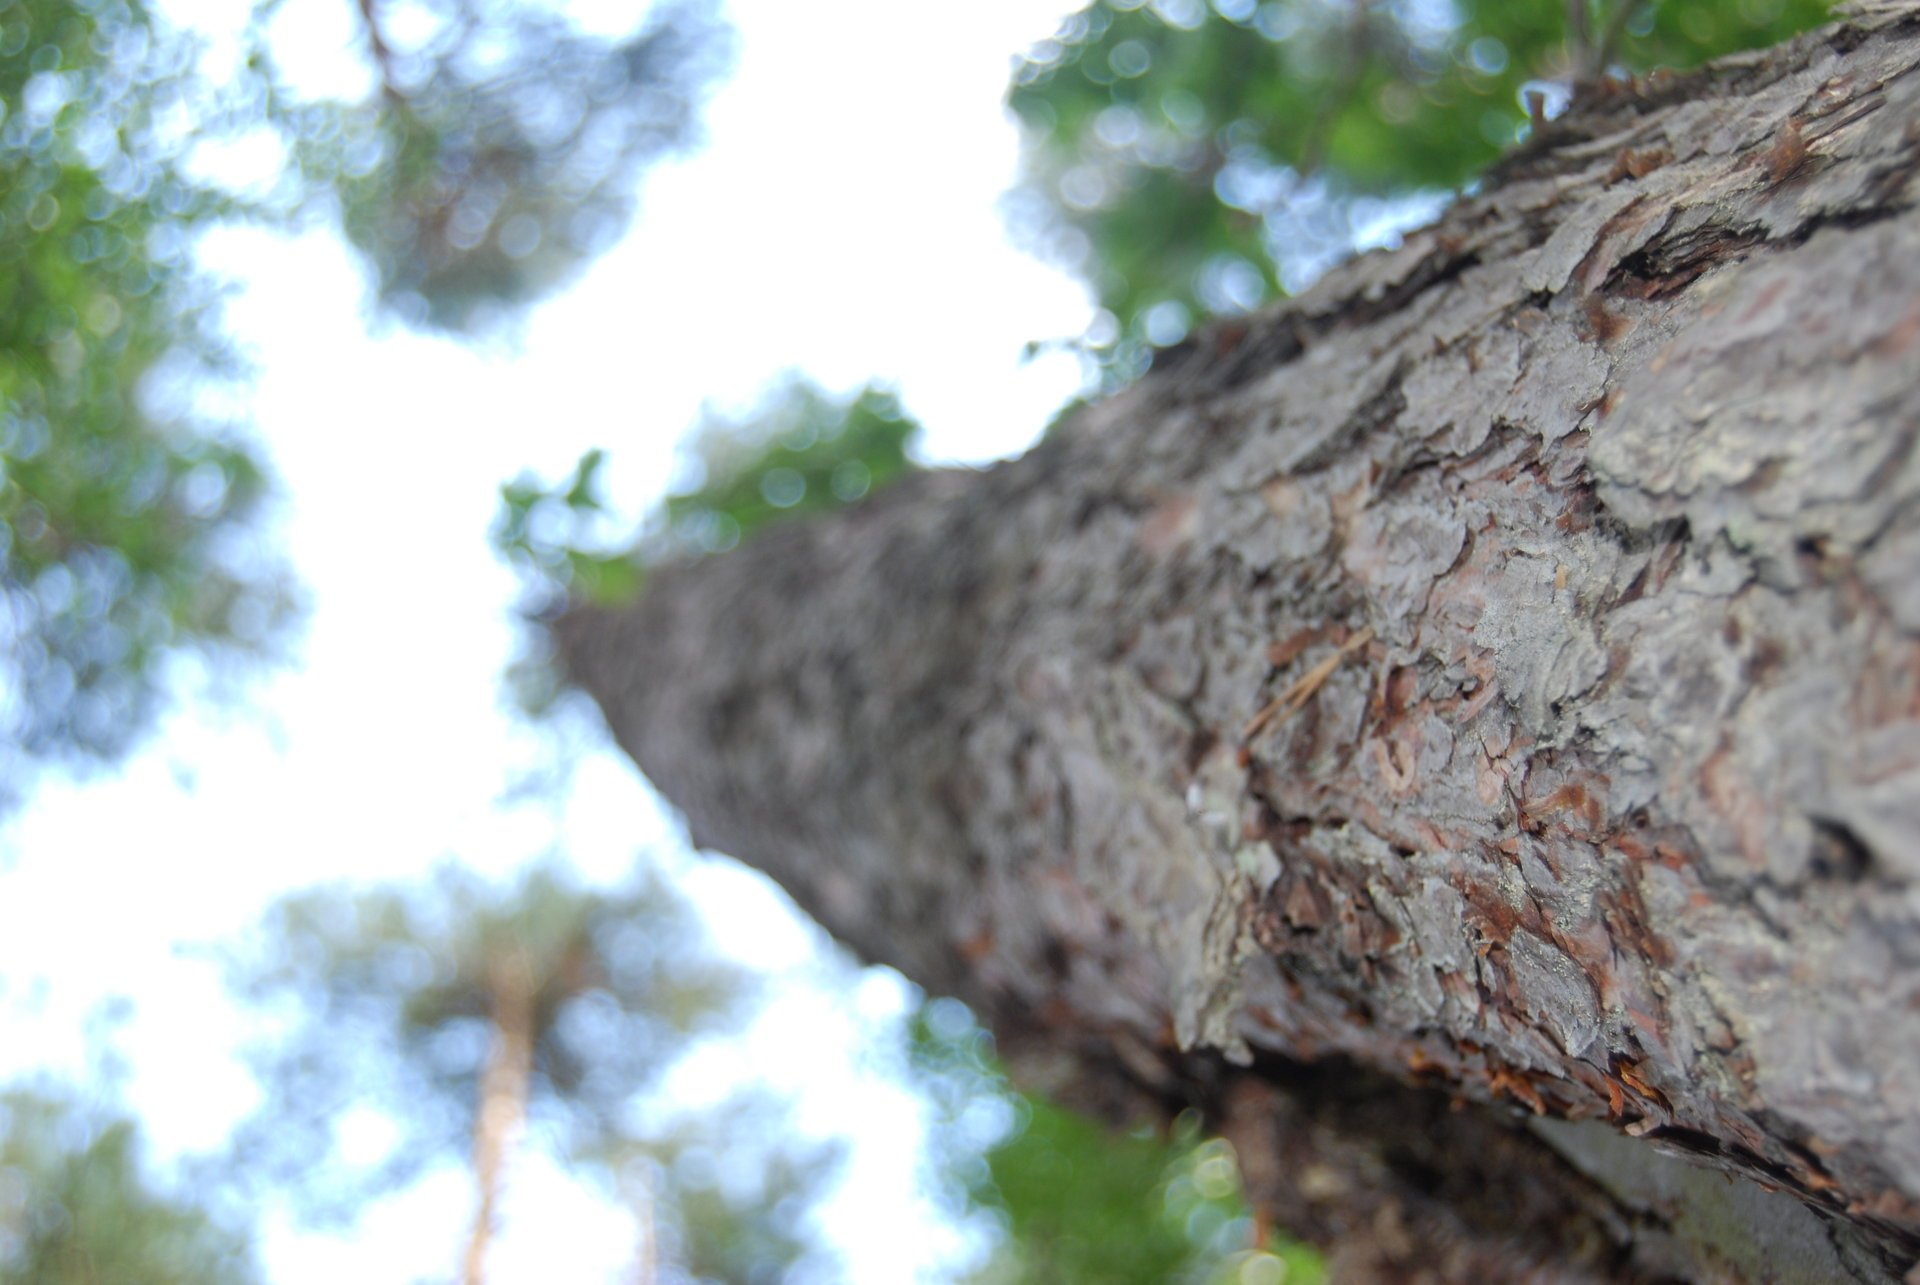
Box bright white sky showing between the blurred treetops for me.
[0,0,1091,1285]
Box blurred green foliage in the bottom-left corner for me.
[0,1087,261,1285]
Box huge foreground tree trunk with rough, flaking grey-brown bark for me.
[555,6,1920,1279]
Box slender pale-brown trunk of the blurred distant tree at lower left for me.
[461,949,536,1285]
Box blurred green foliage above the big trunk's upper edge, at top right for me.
[1008,0,1828,370]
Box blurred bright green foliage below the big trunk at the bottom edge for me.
[912,999,1323,1285]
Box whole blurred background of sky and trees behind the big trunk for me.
[0,0,1822,1281]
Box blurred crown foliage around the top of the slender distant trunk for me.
[227,866,745,1222]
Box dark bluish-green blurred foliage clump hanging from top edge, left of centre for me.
[298,0,728,330]
